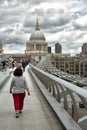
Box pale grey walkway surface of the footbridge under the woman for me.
[0,69,63,130]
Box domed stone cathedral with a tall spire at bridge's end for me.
[26,19,48,61]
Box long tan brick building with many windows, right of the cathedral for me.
[51,54,87,77]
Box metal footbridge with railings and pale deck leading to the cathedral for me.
[0,55,87,130]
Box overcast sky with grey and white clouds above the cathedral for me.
[0,0,87,55]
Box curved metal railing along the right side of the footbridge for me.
[31,65,87,130]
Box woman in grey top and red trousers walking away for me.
[10,67,30,118]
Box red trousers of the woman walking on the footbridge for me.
[13,92,25,111]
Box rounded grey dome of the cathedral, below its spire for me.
[30,30,45,41]
